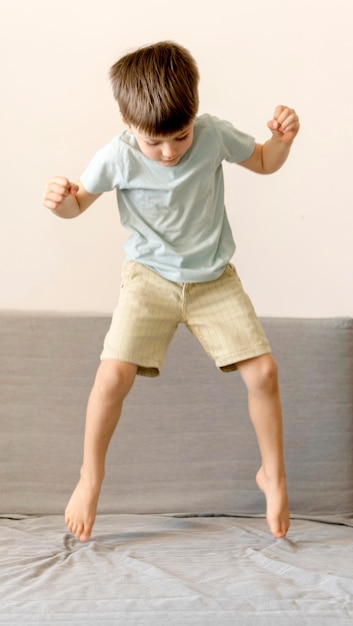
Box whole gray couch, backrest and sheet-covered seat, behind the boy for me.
[0,312,353,626]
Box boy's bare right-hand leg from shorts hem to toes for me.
[238,354,290,538]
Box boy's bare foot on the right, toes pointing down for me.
[256,467,290,539]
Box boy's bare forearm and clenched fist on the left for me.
[43,176,101,219]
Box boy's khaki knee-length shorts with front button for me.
[101,261,271,376]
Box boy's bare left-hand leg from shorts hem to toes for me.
[65,360,137,541]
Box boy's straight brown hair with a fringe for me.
[109,41,199,137]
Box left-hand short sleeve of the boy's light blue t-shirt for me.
[80,138,124,194]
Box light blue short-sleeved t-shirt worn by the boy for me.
[81,115,255,283]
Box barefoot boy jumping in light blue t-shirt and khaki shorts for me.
[44,42,299,541]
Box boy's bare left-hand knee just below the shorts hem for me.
[95,360,137,399]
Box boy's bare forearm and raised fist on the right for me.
[240,105,299,174]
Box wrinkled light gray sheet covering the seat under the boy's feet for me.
[0,515,353,626]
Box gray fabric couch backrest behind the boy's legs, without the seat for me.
[0,312,353,517]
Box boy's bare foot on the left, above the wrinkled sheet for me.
[65,472,101,541]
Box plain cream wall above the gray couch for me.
[0,0,353,317]
